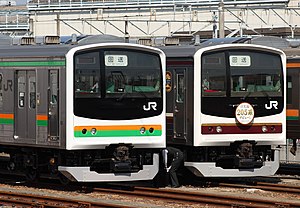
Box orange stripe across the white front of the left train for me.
[74,125,161,131]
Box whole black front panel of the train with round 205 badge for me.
[201,49,284,118]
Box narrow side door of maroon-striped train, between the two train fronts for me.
[174,69,186,140]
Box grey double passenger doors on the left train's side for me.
[14,70,36,144]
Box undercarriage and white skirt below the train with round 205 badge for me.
[185,141,279,177]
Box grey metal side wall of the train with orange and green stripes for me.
[0,55,65,148]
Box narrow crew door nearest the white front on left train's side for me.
[48,70,59,141]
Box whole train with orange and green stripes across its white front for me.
[0,38,166,182]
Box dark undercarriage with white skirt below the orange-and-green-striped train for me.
[0,144,158,183]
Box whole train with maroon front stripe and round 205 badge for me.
[159,38,286,177]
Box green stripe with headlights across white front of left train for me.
[74,130,162,137]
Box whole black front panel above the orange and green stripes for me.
[74,49,163,120]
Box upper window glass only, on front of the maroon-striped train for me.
[202,50,283,98]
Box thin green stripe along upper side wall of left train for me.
[0,61,66,67]
